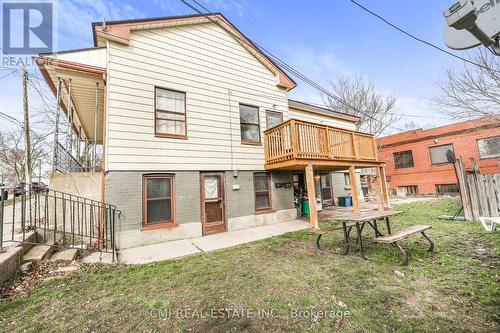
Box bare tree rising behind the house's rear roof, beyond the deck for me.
[323,76,401,136]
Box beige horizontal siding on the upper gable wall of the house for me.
[106,24,288,171]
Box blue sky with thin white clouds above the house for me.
[0,0,462,132]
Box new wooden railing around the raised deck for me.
[264,119,377,164]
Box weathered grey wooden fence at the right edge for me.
[455,159,500,221]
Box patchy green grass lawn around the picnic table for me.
[0,199,500,332]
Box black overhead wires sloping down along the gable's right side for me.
[180,0,404,131]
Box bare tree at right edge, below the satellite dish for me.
[433,48,500,121]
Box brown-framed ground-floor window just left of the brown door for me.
[143,175,175,226]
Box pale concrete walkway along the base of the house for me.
[118,220,309,264]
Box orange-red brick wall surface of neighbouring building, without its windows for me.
[377,118,500,193]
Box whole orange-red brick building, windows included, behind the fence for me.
[377,118,500,194]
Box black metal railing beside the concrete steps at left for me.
[0,185,120,260]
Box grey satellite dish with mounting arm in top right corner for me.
[443,0,500,50]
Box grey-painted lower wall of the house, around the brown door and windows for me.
[104,171,296,248]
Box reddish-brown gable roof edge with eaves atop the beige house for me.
[92,13,297,90]
